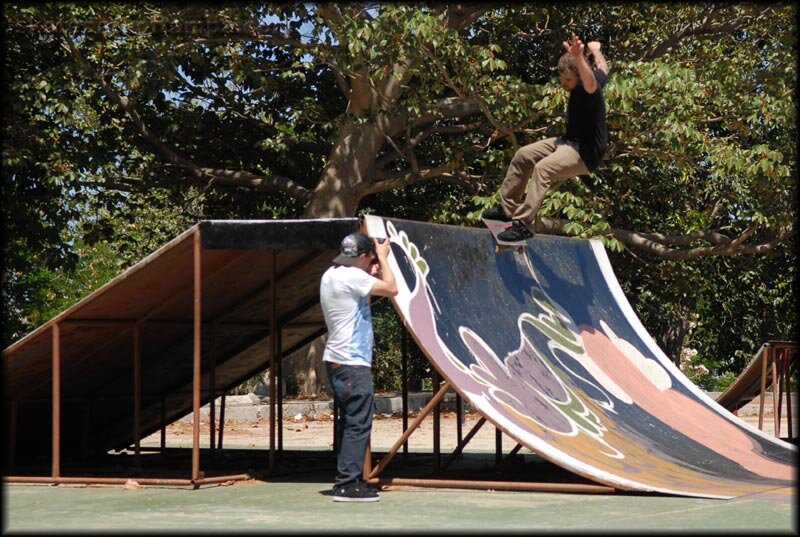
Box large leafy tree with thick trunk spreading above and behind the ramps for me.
[3,3,797,386]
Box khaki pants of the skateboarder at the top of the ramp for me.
[500,138,589,231]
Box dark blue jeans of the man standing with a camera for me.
[325,362,374,487]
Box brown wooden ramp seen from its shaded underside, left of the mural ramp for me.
[0,218,359,460]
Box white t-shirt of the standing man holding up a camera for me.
[319,265,378,367]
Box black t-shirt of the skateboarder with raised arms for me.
[565,69,608,171]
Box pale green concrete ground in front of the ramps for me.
[2,475,798,534]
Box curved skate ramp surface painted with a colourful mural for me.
[367,217,797,498]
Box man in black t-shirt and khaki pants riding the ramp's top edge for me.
[483,34,608,241]
